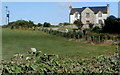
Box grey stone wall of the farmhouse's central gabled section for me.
[81,8,95,24]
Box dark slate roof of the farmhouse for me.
[70,6,107,15]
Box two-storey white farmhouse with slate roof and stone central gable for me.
[69,4,110,24]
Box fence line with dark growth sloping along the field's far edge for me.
[40,29,120,43]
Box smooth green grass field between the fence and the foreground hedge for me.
[2,29,115,60]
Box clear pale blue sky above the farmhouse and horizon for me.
[2,2,118,24]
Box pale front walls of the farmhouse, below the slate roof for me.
[69,4,109,24]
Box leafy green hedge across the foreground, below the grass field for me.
[2,51,120,74]
